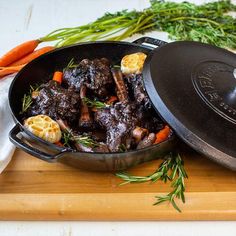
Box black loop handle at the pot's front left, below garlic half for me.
[9,124,67,162]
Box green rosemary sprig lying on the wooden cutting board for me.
[116,154,188,212]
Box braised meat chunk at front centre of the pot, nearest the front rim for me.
[94,102,139,152]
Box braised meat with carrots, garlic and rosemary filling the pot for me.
[21,52,171,152]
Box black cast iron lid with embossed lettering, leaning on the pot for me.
[143,42,236,170]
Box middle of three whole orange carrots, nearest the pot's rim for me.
[10,46,54,66]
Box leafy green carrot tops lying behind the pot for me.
[40,0,236,49]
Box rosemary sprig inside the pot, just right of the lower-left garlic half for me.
[62,130,99,148]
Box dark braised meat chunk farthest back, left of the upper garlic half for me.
[63,58,114,99]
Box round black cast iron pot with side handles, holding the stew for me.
[9,38,175,171]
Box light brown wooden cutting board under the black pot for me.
[0,146,236,220]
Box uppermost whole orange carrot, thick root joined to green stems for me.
[0,40,40,66]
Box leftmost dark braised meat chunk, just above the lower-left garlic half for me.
[28,80,80,124]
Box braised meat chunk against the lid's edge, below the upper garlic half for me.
[124,74,152,108]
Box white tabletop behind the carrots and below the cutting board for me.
[0,0,236,236]
